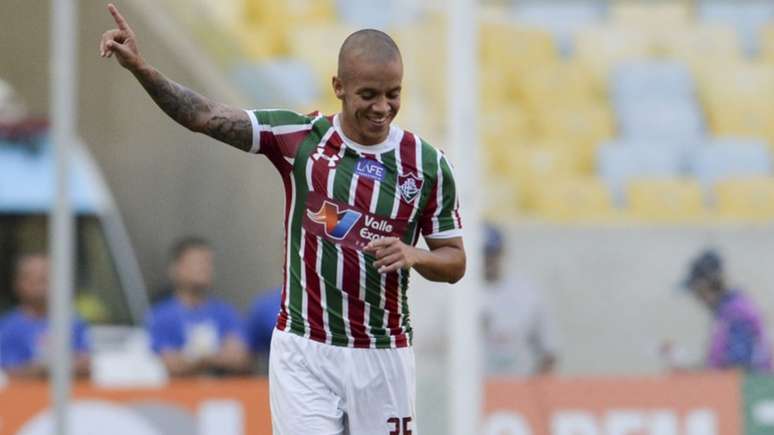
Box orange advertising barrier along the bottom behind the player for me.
[0,373,774,435]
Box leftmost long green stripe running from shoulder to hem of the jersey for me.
[287,118,330,335]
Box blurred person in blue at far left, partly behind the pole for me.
[0,254,90,378]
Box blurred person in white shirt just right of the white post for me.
[483,225,557,376]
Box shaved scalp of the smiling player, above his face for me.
[338,29,402,78]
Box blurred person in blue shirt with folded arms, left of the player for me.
[147,237,250,376]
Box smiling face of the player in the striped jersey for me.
[333,59,403,145]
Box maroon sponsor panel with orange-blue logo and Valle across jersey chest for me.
[303,192,408,250]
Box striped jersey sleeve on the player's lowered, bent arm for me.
[420,153,462,239]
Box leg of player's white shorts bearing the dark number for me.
[345,348,417,435]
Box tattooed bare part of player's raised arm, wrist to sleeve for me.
[135,68,252,151]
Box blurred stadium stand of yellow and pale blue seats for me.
[159,0,774,222]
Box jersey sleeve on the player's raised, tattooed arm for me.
[246,110,321,164]
